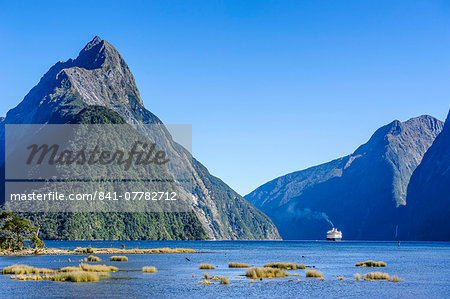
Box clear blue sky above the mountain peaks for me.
[0,0,450,195]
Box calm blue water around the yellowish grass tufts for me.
[0,241,450,298]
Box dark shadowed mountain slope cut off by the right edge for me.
[400,112,450,241]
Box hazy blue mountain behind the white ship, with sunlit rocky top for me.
[245,116,442,240]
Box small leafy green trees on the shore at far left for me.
[0,211,45,253]
